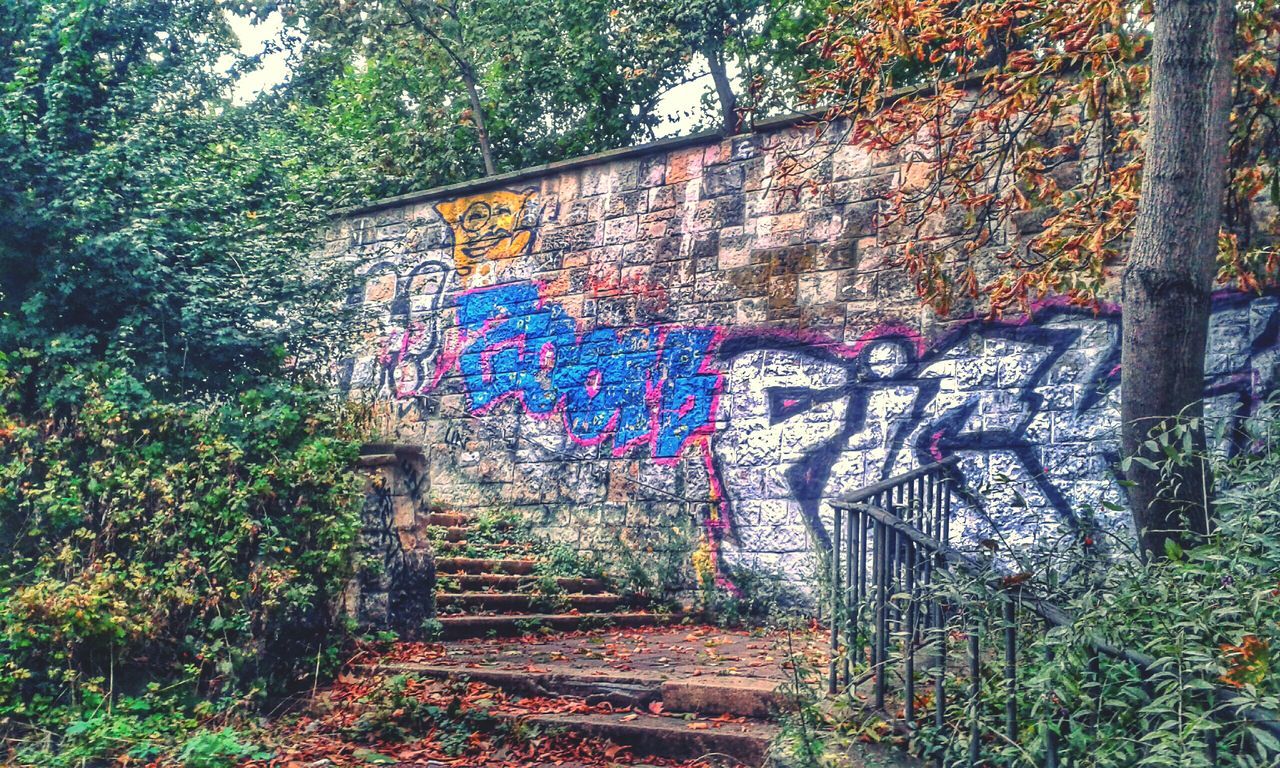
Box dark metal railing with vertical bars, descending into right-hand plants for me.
[828,465,1280,768]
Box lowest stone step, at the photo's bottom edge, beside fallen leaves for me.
[504,712,778,768]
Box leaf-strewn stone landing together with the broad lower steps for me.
[364,625,922,768]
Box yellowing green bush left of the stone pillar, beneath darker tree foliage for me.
[0,353,362,764]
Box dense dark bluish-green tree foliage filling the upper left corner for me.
[0,0,358,401]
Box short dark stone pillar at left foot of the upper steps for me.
[346,443,435,636]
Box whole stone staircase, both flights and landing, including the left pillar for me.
[350,445,918,768]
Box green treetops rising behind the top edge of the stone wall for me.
[234,0,820,197]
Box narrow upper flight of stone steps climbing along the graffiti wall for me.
[426,509,684,640]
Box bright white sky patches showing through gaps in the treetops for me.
[228,13,711,138]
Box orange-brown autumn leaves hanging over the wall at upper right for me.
[805,0,1280,314]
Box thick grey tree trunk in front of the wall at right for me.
[1121,0,1234,557]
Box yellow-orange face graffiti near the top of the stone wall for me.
[435,189,534,284]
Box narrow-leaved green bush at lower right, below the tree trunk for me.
[1033,403,1280,767]
